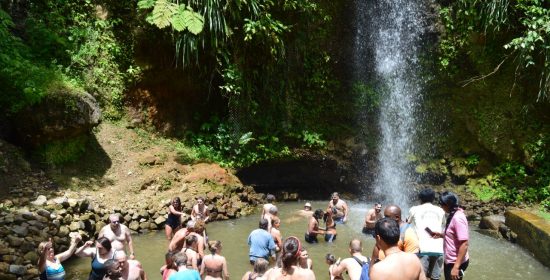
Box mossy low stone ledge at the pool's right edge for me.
[505,210,550,267]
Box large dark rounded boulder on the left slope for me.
[14,89,101,146]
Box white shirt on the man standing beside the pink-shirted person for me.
[407,202,445,254]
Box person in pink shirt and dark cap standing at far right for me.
[432,192,470,280]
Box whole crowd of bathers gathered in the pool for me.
[38,189,469,280]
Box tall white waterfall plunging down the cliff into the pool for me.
[354,0,432,209]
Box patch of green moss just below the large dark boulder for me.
[35,136,88,166]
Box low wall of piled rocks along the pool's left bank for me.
[0,187,262,280]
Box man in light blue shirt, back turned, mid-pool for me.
[248,219,275,265]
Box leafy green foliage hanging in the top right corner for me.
[439,0,550,100]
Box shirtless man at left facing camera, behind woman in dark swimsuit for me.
[97,214,135,260]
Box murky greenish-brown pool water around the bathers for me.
[66,201,550,280]
